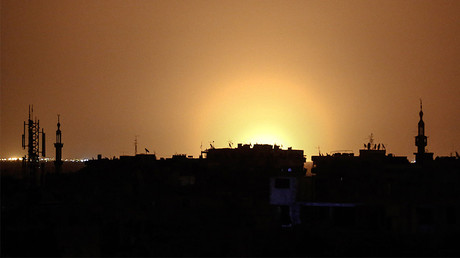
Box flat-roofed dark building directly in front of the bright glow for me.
[204,144,306,226]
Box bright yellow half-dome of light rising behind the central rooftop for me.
[194,74,334,153]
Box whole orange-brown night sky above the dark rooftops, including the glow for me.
[0,0,460,160]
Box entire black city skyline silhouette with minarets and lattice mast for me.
[1,103,460,257]
